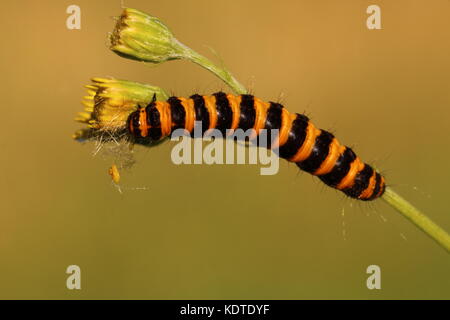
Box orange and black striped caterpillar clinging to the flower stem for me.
[127,92,385,201]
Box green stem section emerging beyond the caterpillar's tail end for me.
[382,187,450,252]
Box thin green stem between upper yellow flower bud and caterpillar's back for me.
[178,43,248,94]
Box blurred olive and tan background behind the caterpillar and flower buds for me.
[0,0,450,299]
